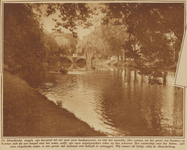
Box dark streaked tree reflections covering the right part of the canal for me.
[87,69,182,136]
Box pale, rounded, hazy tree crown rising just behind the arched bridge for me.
[82,23,127,58]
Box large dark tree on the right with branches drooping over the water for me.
[103,3,184,84]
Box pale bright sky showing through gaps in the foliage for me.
[43,3,103,40]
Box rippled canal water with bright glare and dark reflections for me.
[26,63,183,136]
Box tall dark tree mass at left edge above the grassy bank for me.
[4,4,44,71]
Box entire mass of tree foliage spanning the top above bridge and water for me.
[4,3,184,83]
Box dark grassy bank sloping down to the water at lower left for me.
[3,71,104,136]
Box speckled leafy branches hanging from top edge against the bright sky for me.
[29,3,94,37]
